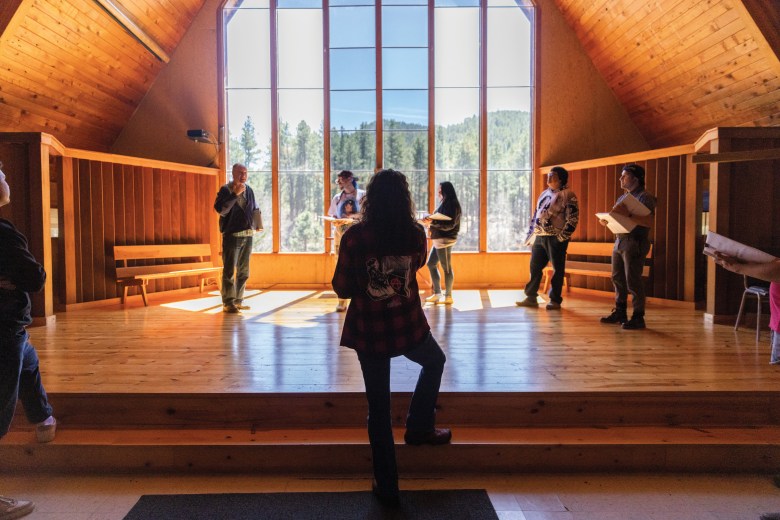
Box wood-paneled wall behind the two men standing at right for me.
[534,146,701,301]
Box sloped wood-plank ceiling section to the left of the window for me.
[0,0,204,151]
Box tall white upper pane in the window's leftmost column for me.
[225,9,271,88]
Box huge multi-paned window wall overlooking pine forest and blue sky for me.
[222,0,534,253]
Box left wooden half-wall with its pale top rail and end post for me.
[0,133,221,318]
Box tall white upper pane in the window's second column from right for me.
[434,9,479,88]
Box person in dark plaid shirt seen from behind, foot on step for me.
[333,170,452,506]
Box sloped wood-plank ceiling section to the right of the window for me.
[554,0,780,147]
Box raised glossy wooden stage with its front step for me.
[0,289,780,473]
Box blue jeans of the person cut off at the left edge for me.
[0,328,52,437]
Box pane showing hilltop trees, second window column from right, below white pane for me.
[436,88,479,170]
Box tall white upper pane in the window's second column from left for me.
[276,9,323,88]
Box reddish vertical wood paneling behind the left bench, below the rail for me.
[60,158,217,304]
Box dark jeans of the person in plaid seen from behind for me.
[358,333,447,493]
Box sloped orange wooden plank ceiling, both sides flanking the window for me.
[0,0,780,151]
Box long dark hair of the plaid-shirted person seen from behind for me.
[361,169,421,256]
